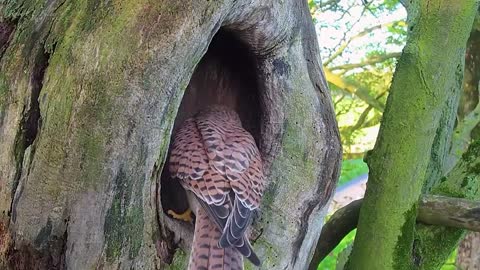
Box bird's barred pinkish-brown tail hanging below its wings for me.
[188,207,243,270]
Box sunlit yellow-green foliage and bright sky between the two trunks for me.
[308,0,406,156]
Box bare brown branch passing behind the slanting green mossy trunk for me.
[309,195,480,270]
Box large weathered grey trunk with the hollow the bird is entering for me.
[0,0,341,269]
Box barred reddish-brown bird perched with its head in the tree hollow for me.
[168,105,265,270]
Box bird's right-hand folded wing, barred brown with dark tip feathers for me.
[196,114,265,253]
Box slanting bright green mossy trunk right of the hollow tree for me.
[347,0,478,269]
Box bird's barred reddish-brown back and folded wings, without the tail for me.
[170,108,264,265]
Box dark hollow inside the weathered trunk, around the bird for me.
[161,30,261,218]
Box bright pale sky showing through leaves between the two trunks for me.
[314,0,407,152]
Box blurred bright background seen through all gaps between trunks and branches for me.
[308,0,480,270]
